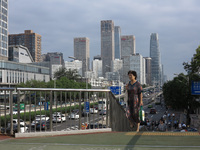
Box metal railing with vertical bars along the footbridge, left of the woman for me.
[0,88,128,135]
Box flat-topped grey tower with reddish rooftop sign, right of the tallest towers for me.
[121,35,136,83]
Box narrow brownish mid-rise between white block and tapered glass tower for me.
[144,57,152,85]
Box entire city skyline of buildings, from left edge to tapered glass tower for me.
[0,0,164,87]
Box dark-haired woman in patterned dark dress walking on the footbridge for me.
[126,70,143,132]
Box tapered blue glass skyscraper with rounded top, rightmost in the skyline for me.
[150,33,162,85]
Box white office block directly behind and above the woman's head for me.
[129,53,146,84]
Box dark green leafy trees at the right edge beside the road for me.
[163,46,200,125]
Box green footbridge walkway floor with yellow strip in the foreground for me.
[0,132,200,150]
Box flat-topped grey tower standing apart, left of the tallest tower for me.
[74,37,90,76]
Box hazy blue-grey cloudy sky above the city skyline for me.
[8,0,200,80]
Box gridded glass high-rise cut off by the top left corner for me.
[0,0,8,60]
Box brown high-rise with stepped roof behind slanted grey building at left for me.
[9,30,42,62]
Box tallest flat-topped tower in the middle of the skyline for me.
[101,20,115,77]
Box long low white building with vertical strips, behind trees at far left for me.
[0,60,50,87]
